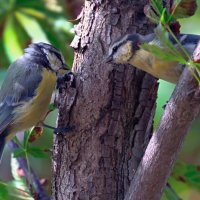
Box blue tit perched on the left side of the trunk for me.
[0,43,66,160]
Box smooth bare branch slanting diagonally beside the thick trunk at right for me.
[125,41,200,200]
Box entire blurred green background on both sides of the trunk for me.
[0,0,200,200]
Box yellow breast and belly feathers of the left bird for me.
[9,68,56,138]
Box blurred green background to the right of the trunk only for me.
[154,0,200,200]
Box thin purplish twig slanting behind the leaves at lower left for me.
[8,140,50,200]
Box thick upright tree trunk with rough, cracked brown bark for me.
[52,0,157,200]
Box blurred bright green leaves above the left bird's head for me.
[0,0,72,67]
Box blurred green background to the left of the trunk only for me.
[0,0,83,199]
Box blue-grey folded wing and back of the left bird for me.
[0,57,42,134]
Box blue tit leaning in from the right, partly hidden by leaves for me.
[106,33,200,83]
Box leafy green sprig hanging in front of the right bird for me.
[141,0,200,84]
